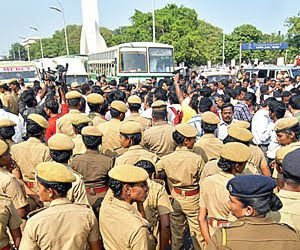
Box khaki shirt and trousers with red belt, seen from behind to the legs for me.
[157,146,205,249]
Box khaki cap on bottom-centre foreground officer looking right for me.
[108,164,148,183]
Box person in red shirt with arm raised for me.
[44,91,69,142]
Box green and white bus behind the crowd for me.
[88,42,174,84]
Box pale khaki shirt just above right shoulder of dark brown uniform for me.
[97,118,121,155]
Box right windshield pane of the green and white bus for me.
[149,48,174,73]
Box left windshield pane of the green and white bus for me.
[120,48,147,73]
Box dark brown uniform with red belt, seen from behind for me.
[70,149,113,208]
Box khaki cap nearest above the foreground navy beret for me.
[221,142,251,162]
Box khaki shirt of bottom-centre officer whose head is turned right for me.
[99,197,149,250]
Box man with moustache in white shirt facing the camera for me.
[217,103,237,140]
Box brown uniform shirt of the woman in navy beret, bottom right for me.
[207,217,300,250]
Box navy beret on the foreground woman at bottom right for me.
[226,175,276,198]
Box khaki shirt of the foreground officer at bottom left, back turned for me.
[20,198,100,250]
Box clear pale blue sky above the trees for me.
[0,0,300,55]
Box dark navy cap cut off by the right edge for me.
[282,148,300,180]
